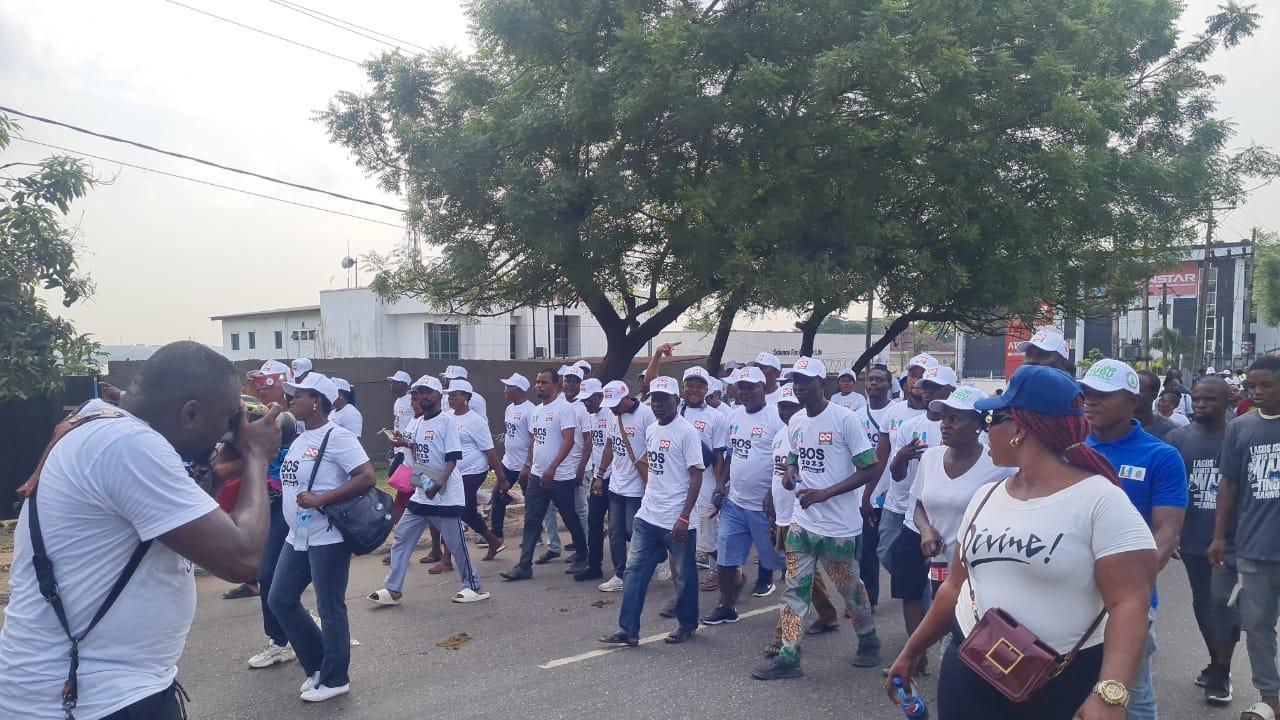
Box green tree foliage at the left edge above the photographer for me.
[0,115,100,400]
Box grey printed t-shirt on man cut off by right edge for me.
[1219,410,1280,562]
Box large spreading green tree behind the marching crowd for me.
[323,0,1256,377]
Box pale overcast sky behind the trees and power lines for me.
[0,0,1280,345]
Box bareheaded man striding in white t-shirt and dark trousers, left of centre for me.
[500,368,586,580]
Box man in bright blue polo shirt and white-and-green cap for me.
[1080,360,1187,720]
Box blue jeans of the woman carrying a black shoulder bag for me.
[268,542,351,688]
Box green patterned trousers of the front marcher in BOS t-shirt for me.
[778,525,876,665]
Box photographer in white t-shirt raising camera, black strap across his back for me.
[0,342,280,720]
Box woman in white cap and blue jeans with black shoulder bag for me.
[268,372,375,702]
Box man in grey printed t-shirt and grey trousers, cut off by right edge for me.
[1208,355,1280,717]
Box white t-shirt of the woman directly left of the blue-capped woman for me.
[911,445,1014,562]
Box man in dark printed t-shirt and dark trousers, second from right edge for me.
[1165,378,1240,705]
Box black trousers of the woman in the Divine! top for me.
[937,628,1102,720]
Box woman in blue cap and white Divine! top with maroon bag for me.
[887,365,1156,720]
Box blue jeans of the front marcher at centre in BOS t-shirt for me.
[618,518,698,638]
